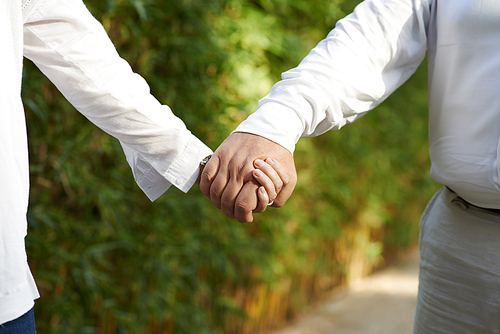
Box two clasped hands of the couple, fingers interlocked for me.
[199,132,297,223]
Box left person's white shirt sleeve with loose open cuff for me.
[23,0,212,200]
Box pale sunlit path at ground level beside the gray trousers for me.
[273,254,418,334]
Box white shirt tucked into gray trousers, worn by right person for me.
[236,0,500,209]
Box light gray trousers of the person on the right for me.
[414,187,500,334]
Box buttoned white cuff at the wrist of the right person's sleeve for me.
[234,102,304,154]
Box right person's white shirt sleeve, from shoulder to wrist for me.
[235,0,430,152]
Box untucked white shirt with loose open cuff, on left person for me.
[0,0,211,324]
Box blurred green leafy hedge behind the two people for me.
[23,0,439,334]
